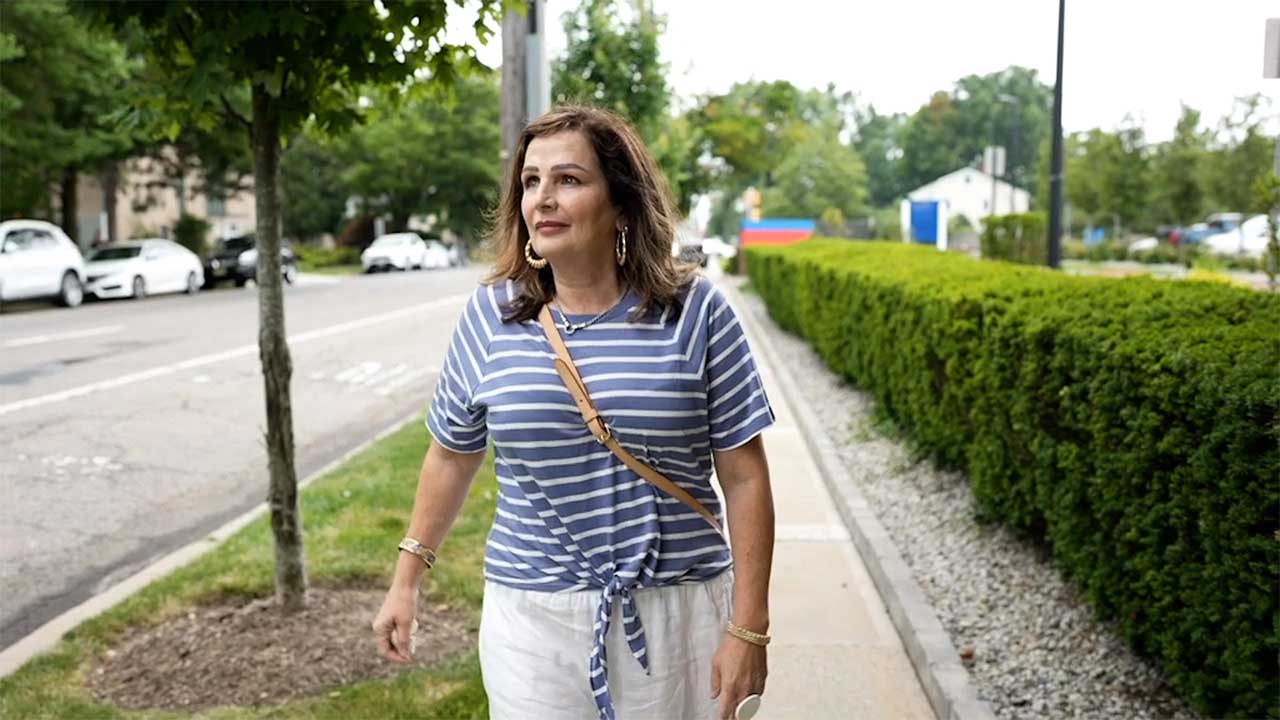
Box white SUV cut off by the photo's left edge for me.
[0,220,84,307]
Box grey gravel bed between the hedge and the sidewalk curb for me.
[739,285,1199,720]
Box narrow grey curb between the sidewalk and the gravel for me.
[723,279,996,720]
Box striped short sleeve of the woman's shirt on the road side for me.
[426,288,489,452]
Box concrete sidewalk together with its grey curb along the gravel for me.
[716,271,993,720]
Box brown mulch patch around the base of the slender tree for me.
[87,588,476,710]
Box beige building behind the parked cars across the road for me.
[77,151,257,249]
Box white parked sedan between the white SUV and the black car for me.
[84,238,205,300]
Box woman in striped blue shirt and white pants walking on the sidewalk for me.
[374,106,773,720]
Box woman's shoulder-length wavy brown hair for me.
[485,105,696,323]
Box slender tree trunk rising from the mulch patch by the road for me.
[252,85,307,612]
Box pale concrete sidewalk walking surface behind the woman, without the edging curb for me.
[721,281,934,720]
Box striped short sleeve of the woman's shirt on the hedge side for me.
[707,287,774,450]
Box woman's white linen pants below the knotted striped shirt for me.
[480,570,733,720]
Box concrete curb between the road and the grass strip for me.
[0,410,422,678]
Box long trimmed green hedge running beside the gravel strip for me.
[748,240,1280,717]
